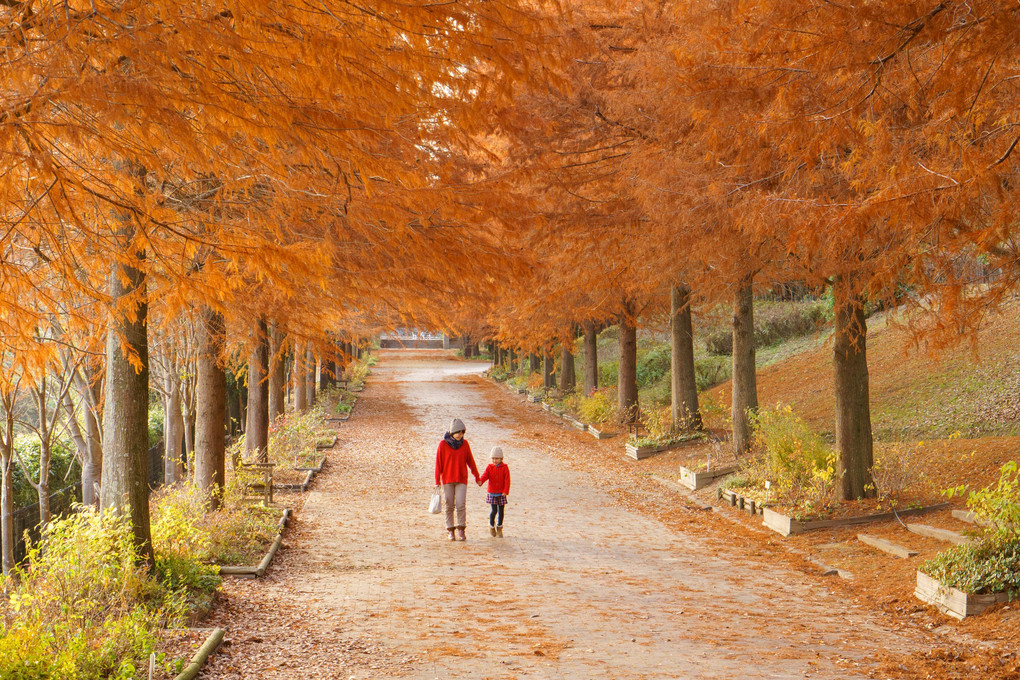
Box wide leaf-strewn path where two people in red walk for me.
[202,353,922,680]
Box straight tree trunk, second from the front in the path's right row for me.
[732,276,758,456]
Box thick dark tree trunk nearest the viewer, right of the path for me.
[832,277,876,501]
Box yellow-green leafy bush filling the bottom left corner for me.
[0,509,185,680]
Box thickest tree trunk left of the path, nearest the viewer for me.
[100,244,155,566]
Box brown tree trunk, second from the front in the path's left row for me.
[195,309,226,510]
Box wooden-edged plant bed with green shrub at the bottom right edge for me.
[914,461,1020,619]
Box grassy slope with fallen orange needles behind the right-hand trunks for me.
[708,303,1020,440]
